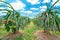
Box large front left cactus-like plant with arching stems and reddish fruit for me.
[0,1,20,32]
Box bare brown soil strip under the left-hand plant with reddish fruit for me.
[2,30,23,40]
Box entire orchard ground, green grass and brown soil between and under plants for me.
[0,21,60,40]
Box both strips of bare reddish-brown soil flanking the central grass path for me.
[2,30,60,40]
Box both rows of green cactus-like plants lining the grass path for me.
[0,0,60,34]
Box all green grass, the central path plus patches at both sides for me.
[0,22,60,40]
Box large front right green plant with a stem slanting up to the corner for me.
[35,0,60,32]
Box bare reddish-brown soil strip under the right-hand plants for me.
[34,30,60,40]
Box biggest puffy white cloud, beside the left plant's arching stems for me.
[10,0,26,10]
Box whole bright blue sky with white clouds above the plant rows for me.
[1,0,60,18]
